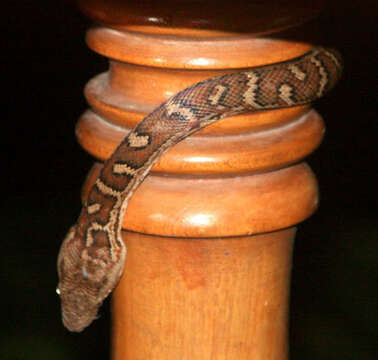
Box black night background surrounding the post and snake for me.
[0,0,378,360]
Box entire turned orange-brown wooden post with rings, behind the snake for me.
[77,0,330,360]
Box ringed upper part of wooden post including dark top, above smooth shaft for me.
[77,1,324,237]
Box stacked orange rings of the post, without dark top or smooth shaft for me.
[76,27,324,237]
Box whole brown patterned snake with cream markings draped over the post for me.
[57,48,341,331]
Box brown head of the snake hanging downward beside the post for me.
[56,226,124,332]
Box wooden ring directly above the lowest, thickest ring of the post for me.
[76,108,324,176]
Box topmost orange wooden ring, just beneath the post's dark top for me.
[86,26,310,69]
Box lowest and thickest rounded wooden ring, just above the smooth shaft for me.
[84,163,318,237]
